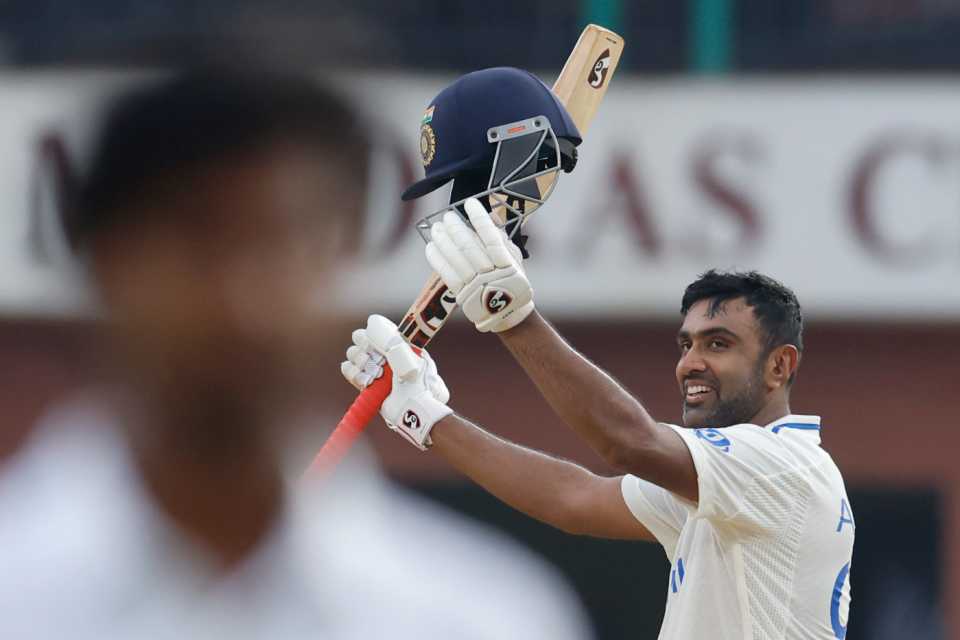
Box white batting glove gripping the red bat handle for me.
[340,315,453,451]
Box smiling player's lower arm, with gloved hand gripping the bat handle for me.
[341,316,654,540]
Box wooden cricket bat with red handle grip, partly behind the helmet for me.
[313,24,624,469]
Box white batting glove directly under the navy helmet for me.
[426,198,533,332]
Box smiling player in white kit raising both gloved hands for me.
[342,200,854,640]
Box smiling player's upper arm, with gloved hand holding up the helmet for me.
[426,200,698,501]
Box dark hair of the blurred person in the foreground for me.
[63,68,369,249]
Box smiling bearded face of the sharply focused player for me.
[676,298,767,428]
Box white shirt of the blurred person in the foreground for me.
[0,398,589,640]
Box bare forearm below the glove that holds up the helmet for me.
[498,312,657,467]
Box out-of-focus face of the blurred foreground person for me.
[94,145,359,408]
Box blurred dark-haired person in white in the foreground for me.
[0,72,583,640]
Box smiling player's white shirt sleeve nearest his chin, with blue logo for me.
[668,425,810,534]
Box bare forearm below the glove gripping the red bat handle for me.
[430,415,598,534]
